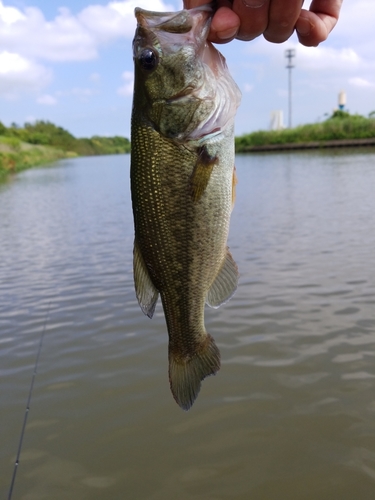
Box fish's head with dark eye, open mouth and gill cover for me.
[133,5,239,142]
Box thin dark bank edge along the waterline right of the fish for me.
[236,137,375,153]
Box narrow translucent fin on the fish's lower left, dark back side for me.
[133,240,159,318]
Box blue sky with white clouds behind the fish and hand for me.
[0,0,375,137]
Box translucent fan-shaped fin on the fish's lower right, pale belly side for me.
[206,249,238,308]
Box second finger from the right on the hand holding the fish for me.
[263,0,303,43]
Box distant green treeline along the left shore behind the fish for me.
[0,121,130,156]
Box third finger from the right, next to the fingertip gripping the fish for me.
[232,0,270,40]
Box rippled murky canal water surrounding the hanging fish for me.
[0,149,375,500]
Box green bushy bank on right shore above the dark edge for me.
[236,110,375,153]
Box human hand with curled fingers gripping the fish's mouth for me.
[184,0,343,47]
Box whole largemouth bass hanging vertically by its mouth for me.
[130,5,241,410]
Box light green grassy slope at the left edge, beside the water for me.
[0,136,77,181]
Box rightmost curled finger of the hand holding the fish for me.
[296,0,342,47]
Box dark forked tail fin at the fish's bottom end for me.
[169,334,220,411]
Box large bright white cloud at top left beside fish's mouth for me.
[0,0,173,61]
